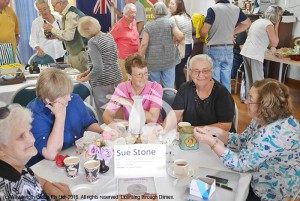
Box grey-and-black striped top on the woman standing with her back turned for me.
[88,33,122,87]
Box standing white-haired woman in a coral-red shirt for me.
[110,3,140,81]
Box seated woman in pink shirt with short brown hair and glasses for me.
[103,54,163,125]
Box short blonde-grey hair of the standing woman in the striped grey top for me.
[78,16,101,39]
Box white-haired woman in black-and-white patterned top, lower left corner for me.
[0,102,71,200]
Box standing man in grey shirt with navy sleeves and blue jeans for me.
[200,0,251,93]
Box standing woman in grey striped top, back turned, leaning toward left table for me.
[77,16,122,124]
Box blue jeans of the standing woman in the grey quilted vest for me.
[149,66,175,93]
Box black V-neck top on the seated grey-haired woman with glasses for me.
[172,81,234,132]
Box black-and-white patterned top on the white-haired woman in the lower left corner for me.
[0,160,51,201]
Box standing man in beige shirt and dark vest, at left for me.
[43,0,88,73]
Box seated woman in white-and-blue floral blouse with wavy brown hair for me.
[194,79,300,200]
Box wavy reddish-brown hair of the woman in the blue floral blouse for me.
[252,79,293,124]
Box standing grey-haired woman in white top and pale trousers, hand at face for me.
[240,5,283,98]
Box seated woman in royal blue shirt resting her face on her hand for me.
[27,68,102,166]
